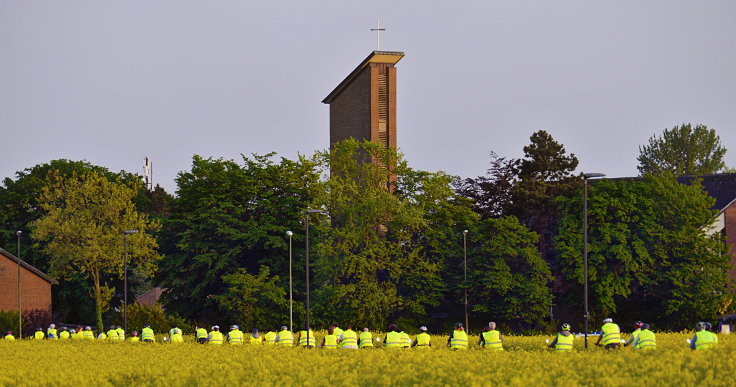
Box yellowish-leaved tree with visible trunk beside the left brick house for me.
[30,172,159,329]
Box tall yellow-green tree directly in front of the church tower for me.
[314,139,452,326]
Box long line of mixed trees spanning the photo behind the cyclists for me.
[0,124,734,331]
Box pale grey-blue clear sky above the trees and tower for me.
[0,0,736,193]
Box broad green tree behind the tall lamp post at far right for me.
[556,174,733,328]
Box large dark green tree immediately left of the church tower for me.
[157,154,320,322]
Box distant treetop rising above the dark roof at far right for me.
[637,124,726,176]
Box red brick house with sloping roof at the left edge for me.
[0,249,59,314]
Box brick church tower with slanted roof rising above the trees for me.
[322,51,404,149]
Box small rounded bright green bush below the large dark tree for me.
[217,266,289,328]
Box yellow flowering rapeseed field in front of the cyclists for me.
[0,333,736,386]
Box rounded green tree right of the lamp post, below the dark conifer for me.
[468,217,552,323]
